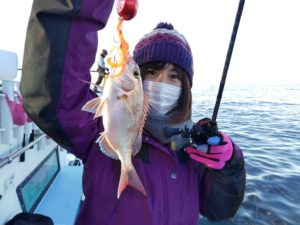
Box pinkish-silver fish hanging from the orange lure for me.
[82,57,149,199]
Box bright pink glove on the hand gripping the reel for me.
[186,132,233,170]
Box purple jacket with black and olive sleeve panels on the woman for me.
[21,0,245,225]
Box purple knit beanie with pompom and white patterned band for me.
[133,22,194,85]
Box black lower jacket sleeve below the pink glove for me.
[199,143,246,221]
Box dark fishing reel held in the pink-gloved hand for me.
[164,118,221,151]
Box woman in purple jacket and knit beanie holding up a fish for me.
[21,0,245,225]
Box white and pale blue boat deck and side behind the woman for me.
[0,50,83,225]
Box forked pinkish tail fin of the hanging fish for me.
[118,166,146,198]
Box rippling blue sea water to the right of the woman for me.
[193,83,300,225]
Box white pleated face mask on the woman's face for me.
[143,80,181,114]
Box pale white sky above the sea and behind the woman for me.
[0,0,300,86]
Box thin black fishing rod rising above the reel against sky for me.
[212,0,245,121]
